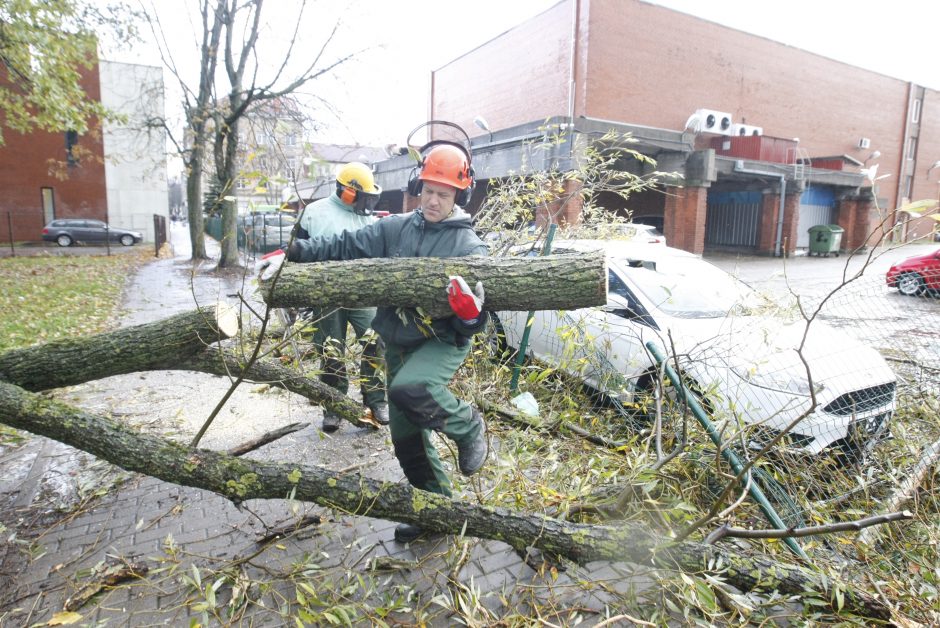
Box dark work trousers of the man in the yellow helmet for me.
[311,308,385,406]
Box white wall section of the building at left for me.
[98,61,169,242]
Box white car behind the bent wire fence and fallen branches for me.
[496,240,895,454]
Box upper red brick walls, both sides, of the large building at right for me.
[432,0,940,215]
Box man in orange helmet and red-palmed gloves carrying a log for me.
[267,142,487,543]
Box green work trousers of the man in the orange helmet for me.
[385,339,483,496]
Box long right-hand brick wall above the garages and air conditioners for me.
[586,0,912,195]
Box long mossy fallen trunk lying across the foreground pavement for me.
[0,382,891,620]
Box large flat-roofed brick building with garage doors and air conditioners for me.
[372,0,940,254]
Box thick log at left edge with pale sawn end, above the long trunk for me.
[0,305,238,391]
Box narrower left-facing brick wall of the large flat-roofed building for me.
[431,2,571,141]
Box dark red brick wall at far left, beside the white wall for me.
[0,66,108,244]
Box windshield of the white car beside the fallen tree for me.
[617,257,753,318]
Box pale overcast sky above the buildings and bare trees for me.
[114,0,940,167]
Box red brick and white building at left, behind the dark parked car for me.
[0,61,168,244]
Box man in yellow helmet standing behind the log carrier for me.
[295,161,389,432]
